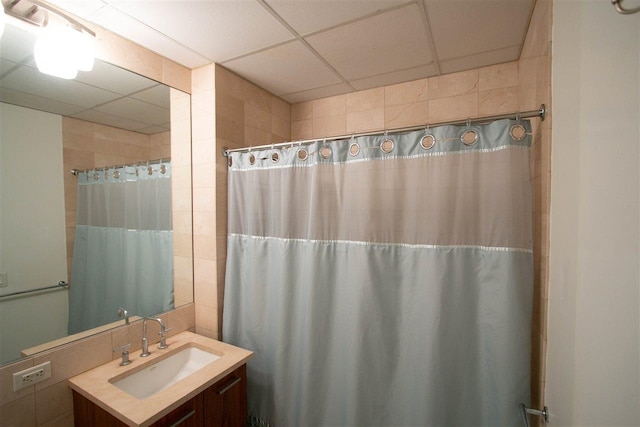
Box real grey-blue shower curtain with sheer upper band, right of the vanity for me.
[223,120,533,427]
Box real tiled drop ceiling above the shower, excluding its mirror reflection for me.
[37,0,535,103]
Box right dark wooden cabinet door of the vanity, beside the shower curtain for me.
[203,365,247,427]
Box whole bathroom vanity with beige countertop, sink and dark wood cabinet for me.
[69,332,252,427]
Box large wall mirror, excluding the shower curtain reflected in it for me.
[0,25,193,365]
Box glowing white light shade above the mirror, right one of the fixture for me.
[33,26,78,79]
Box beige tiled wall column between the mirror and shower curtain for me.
[192,65,290,338]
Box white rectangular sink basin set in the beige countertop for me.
[112,347,220,399]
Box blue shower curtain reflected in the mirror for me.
[68,162,173,334]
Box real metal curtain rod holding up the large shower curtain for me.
[222,104,547,157]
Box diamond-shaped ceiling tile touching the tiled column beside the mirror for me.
[222,41,340,95]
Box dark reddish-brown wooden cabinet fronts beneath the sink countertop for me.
[73,365,247,427]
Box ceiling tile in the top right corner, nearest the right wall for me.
[425,0,535,61]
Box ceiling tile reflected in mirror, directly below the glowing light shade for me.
[2,66,119,108]
